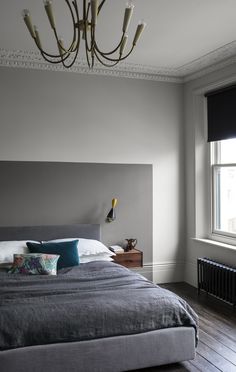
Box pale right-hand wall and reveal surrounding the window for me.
[184,64,236,286]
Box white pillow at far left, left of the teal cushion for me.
[0,240,33,263]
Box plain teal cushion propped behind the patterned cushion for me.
[26,240,79,269]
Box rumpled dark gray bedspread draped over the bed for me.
[0,261,197,350]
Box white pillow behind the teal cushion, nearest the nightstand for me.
[43,238,115,257]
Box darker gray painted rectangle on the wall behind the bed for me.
[0,162,152,262]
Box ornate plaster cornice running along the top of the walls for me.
[0,41,236,83]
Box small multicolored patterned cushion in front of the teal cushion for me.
[9,253,60,275]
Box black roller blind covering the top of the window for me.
[205,85,236,142]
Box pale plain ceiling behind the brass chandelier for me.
[0,0,236,79]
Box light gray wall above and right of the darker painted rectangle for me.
[0,68,185,282]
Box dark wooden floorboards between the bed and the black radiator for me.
[140,283,236,372]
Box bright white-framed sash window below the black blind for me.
[211,139,236,240]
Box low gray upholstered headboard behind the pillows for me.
[0,224,101,241]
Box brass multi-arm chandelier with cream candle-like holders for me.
[22,0,146,68]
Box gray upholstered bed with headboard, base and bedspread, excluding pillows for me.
[0,225,197,372]
